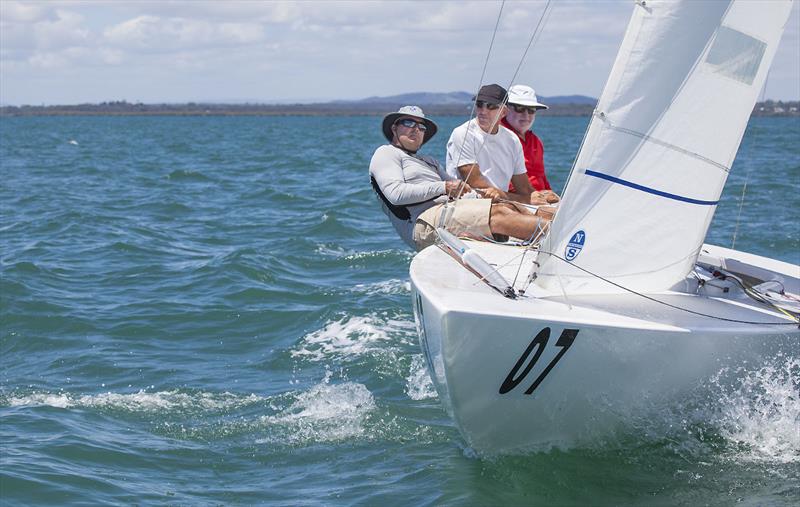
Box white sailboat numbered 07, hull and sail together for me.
[410,0,800,454]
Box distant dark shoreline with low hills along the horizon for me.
[0,100,800,117]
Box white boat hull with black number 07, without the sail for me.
[411,243,800,454]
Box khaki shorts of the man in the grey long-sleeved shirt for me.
[414,199,492,251]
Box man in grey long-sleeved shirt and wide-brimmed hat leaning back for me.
[369,106,552,251]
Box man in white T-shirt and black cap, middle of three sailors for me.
[446,84,547,204]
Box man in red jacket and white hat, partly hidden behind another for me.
[500,85,558,202]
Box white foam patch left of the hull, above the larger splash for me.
[291,314,415,361]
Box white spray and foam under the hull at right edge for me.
[629,355,800,466]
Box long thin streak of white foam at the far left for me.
[5,390,263,413]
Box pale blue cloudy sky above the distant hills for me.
[0,0,800,105]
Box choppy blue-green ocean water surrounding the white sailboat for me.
[0,115,800,506]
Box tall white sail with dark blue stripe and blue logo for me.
[537,0,792,293]
